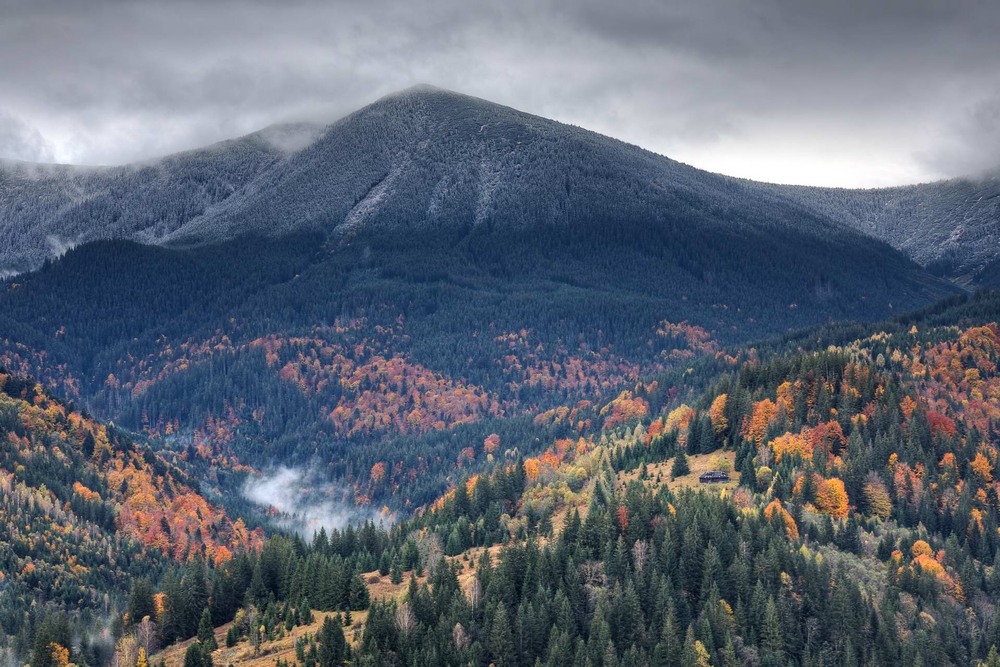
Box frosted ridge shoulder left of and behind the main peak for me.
[0,124,320,276]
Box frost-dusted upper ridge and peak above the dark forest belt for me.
[0,85,984,283]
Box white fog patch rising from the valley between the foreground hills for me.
[243,466,385,538]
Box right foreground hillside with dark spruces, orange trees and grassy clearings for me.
[109,294,1000,665]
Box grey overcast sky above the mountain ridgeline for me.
[0,0,1000,186]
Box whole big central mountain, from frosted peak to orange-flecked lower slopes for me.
[0,88,958,508]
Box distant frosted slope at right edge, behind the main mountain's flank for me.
[762,174,1000,286]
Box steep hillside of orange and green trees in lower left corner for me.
[0,371,263,664]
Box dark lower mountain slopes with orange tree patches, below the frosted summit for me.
[0,185,950,520]
